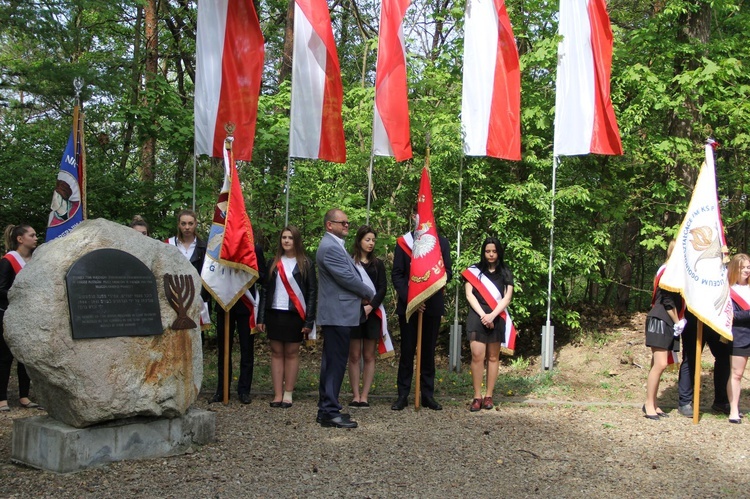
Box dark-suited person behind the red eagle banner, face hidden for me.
[391,209,453,411]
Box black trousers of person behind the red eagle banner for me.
[396,313,441,398]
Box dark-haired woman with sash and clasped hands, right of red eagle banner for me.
[462,237,513,412]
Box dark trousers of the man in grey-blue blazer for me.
[318,326,354,419]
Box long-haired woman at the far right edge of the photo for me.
[727,253,750,424]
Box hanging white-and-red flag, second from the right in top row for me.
[461,0,521,160]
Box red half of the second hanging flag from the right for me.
[487,0,521,161]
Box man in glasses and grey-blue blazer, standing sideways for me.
[316,209,373,428]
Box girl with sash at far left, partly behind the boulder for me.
[0,224,39,412]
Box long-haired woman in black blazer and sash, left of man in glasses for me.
[258,229,318,409]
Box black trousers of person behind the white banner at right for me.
[677,312,732,406]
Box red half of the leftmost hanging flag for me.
[212,0,264,161]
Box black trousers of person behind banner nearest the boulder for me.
[216,304,255,395]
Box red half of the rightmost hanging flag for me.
[588,0,622,154]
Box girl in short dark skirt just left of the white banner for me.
[641,240,687,421]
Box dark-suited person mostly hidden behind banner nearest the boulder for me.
[209,244,267,404]
